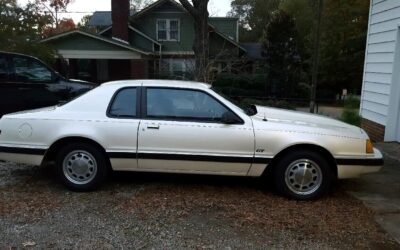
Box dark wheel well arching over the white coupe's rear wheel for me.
[42,136,109,164]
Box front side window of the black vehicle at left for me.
[12,56,52,82]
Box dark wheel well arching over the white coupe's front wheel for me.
[263,144,338,177]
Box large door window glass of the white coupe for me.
[147,88,228,122]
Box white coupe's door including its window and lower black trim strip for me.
[138,87,254,175]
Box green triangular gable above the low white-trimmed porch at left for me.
[46,34,126,51]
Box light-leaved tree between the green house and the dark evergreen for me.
[228,0,282,42]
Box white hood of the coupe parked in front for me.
[253,106,365,138]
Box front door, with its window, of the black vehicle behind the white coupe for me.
[11,55,67,109]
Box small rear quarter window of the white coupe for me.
[108,88,137,118]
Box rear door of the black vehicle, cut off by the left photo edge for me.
[0,53,23,117]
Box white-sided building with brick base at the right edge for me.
[360,0,400,142]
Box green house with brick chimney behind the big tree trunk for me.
[41,0,246,82]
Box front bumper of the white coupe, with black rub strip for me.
[336,148,384,179]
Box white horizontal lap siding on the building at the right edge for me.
[360,0,400,125]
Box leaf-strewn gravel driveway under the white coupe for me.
[0,162,400,249]
